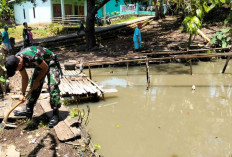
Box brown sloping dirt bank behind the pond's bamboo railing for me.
[55,16,227,62]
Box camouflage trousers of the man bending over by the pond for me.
[27,65,61,110]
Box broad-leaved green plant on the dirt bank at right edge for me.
[210,28,231,48]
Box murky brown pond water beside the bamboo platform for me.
[81,60,232,157]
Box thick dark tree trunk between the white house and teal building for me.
[85,0,96,50]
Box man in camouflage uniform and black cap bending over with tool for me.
[5,46,61,127]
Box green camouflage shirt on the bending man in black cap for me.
[16,46,54,68]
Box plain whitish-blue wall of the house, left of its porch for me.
[14,0,51,24]
